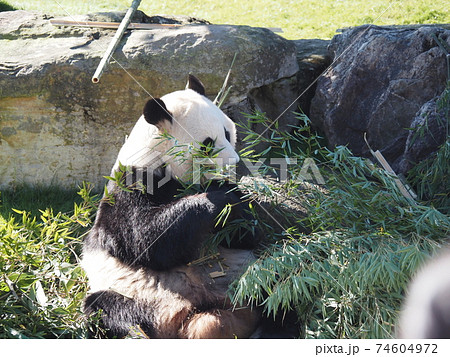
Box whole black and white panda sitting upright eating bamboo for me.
[82,76,260,338]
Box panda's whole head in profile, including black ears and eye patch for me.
[113,75,239,181]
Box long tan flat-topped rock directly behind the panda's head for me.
[0,11,298,187]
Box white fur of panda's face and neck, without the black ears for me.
[112,89,239,180]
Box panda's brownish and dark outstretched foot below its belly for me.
[180,308,260,338]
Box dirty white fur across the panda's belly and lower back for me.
[81,248,255,337]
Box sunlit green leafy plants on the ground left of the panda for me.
[0,186,96,338]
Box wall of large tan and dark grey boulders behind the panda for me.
[0,11,450,188]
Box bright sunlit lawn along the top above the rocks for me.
[4,0,450,39]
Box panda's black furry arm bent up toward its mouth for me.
[94,186,240,270]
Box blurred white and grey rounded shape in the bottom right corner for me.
[396,248,450,339]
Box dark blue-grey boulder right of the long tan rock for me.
[311,26,450,169]
